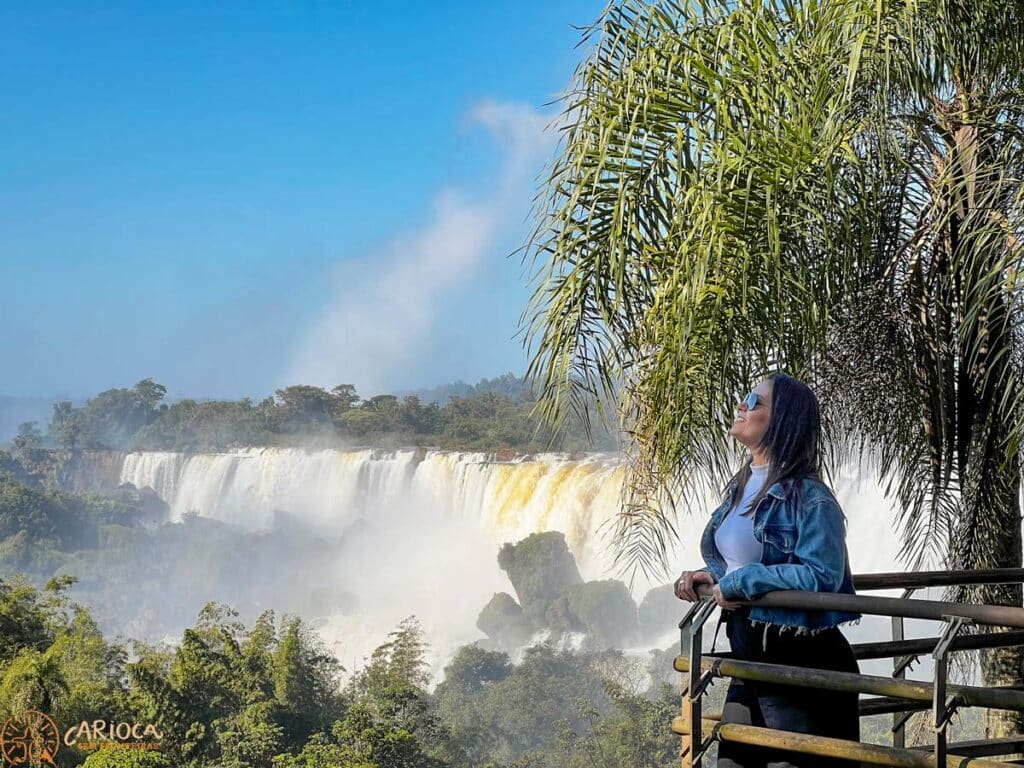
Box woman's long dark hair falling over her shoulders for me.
[726,373,821,510]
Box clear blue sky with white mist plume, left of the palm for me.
[0,0,604,397]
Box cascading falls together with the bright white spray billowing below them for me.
[108,449,898,674]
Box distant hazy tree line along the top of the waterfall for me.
[19,374,616,455]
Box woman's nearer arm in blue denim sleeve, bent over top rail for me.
[719,494,846,600]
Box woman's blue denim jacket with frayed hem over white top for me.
[700,477,860,632]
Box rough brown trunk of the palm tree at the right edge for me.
[940,100,1024,737]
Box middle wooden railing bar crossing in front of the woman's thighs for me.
[673,656,1024,712]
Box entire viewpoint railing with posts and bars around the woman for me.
[672,568,1024,768]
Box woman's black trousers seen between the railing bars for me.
[718,609,860,768]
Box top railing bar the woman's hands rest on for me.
[697,585,1024,629]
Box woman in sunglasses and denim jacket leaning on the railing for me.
[676,374,860,768]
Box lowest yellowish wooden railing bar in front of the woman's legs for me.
[672,717,1013,768]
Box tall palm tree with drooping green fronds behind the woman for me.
[524,0,1024,728]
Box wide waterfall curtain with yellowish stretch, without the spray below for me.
[121,447,898,579]
